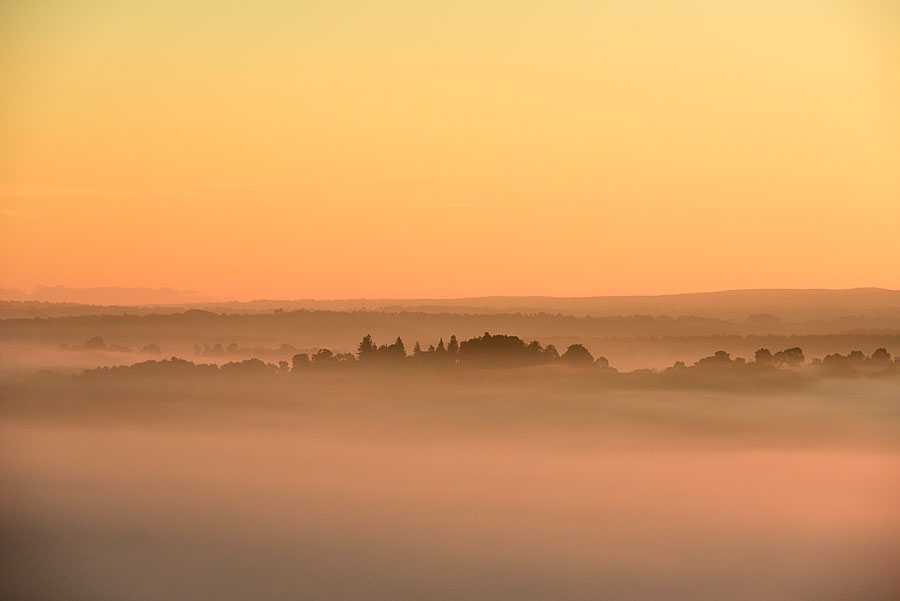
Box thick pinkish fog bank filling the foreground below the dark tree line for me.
[0,368,900,601]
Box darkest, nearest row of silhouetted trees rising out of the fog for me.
[79,332,900,384]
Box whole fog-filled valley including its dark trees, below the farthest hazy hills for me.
[0,296,900,601]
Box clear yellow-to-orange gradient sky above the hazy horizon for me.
[0,0,900,299]
